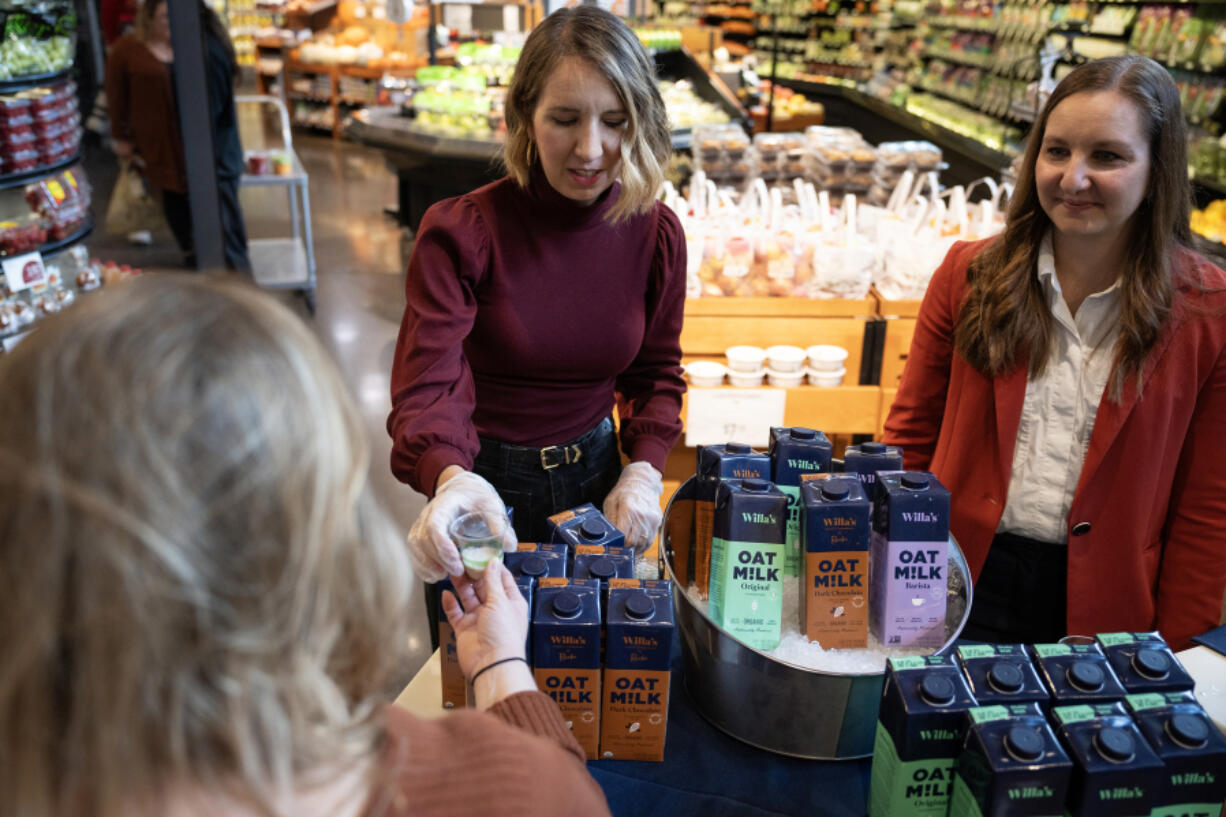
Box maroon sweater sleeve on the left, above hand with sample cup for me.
[387,196,489,497]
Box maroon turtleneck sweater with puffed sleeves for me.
[387,169,685,496]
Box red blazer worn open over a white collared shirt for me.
[885,239,1226,649]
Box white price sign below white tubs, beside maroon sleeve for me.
[685,389,787,448]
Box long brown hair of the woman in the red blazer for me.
[954,56,1192,402]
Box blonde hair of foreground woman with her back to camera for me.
[0,276,411,817]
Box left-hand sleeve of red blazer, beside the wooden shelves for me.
[883,242,972,471]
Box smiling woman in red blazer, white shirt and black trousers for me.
[885,56,1226,649]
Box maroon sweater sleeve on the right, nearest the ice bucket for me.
[615,204,685,472]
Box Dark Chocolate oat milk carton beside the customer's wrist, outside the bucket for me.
[532,579,601,757]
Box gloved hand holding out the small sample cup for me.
[408,471,517,583]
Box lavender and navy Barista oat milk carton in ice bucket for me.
[868,471,949,648]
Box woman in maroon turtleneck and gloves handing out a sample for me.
[387,6,685,580]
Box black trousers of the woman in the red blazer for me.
[962,534,1068,644]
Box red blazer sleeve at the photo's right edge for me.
[1157,295,1226,650]
